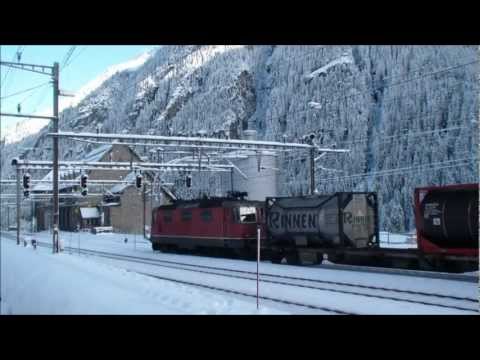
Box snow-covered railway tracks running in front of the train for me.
[2,232,478,314]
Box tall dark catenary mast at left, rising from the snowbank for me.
[52,62,60,253]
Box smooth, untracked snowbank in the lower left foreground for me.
[1,238,281,314]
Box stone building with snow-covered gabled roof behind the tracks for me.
[32,144,175,234]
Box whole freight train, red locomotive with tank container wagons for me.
[151,184,478,272]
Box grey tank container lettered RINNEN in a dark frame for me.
[266,192,379,249]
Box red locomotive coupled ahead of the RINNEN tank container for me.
[151,196,265,258]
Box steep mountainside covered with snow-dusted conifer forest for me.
[2,45,479,232]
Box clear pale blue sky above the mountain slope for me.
[0,45,153,136]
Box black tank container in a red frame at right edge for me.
[415,184,478,268]
